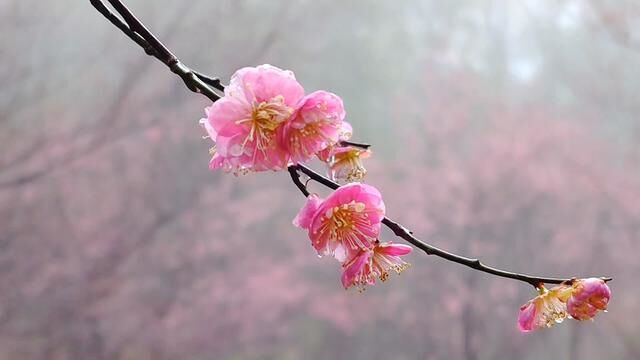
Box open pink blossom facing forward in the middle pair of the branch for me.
[294,183,385,261]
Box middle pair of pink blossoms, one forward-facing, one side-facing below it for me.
[293,183,411,291]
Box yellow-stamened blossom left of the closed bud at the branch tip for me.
[518,285,571,332]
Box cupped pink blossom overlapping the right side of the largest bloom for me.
[281,91,345,162]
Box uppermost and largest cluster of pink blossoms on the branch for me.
[200,65,369,181]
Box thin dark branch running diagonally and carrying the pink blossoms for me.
[90,0,612,287]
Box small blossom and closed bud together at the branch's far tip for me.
[518,278,611,332]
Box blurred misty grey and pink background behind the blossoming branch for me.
[0,0,640,360]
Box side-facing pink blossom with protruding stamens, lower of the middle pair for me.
[342,241,411,291]
